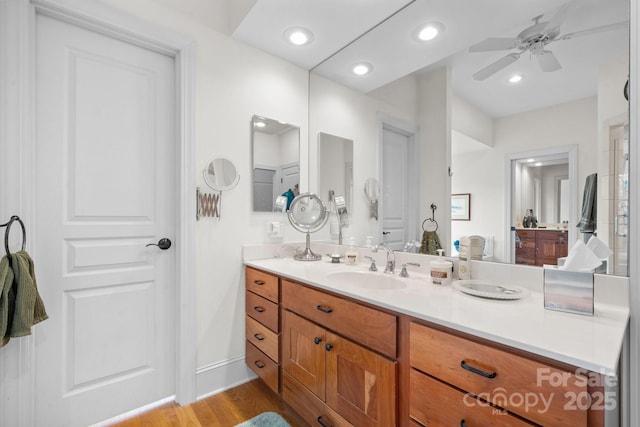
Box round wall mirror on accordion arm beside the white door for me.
[196,158,240,220]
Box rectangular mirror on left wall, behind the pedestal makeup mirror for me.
[251,116,300,212]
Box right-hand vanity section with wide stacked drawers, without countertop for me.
[409,322,602,427]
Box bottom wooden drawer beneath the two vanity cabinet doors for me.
[282,371,353,427]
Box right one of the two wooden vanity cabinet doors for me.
[325,332,397,427]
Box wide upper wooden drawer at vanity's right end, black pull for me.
[409,323,589,426]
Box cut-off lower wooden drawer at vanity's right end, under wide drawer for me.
[409,369,532,427]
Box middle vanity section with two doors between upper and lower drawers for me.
[282,280,397,427]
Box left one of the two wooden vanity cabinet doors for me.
[282,310,326,401]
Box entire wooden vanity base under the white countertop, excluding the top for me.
[246,266,605,427]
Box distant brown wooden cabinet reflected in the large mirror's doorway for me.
[515,228,568,266]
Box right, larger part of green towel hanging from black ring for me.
[11,251,49,337]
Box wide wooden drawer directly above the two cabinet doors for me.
[282,280,397,359]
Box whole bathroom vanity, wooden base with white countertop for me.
[245,259,628,427]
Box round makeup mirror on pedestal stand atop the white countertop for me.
[287,193,329,261]
